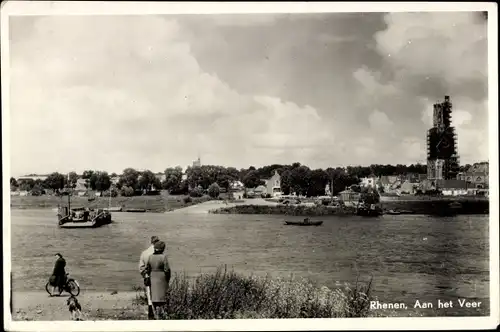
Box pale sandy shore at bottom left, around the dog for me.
[12,291,147,321]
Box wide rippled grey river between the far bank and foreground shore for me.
[11,210,489,315]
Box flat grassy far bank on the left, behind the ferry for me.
[10,192,210,213]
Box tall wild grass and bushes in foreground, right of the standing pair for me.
[137,268,371,319]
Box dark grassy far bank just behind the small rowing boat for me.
[210,205,355,216]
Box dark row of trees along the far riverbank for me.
[10,162,470,196]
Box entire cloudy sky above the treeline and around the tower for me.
[9,12,488,175]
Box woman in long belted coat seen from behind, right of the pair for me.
[146,241,171,311]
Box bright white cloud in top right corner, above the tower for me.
[375,12,487,89]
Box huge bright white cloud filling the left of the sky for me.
[7,16,334,172]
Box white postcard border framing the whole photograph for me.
[1,1,499,331]
